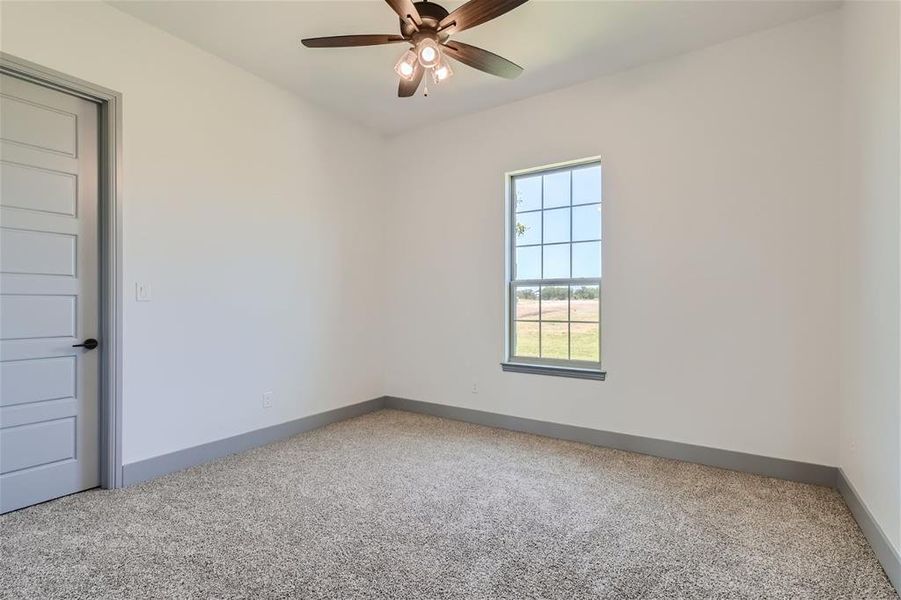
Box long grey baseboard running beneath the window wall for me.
[385,396,837,487]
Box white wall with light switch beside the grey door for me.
[0,2,382,463]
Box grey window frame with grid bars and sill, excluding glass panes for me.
[501,156,606,380]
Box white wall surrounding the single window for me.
[386,12,840,465]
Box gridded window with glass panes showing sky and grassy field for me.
[503,161,604,379]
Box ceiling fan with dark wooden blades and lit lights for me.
[301,0,527,98]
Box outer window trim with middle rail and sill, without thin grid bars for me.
[501,156,607,381]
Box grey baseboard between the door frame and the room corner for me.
[122,398,385,486]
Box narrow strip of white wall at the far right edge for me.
[839,2,901,551]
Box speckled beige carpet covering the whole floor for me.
[0,410,897,600]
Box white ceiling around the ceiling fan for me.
[112,0,839,135]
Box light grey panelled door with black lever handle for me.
[0,75,102,512]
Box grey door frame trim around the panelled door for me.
[0,52,124,488]
